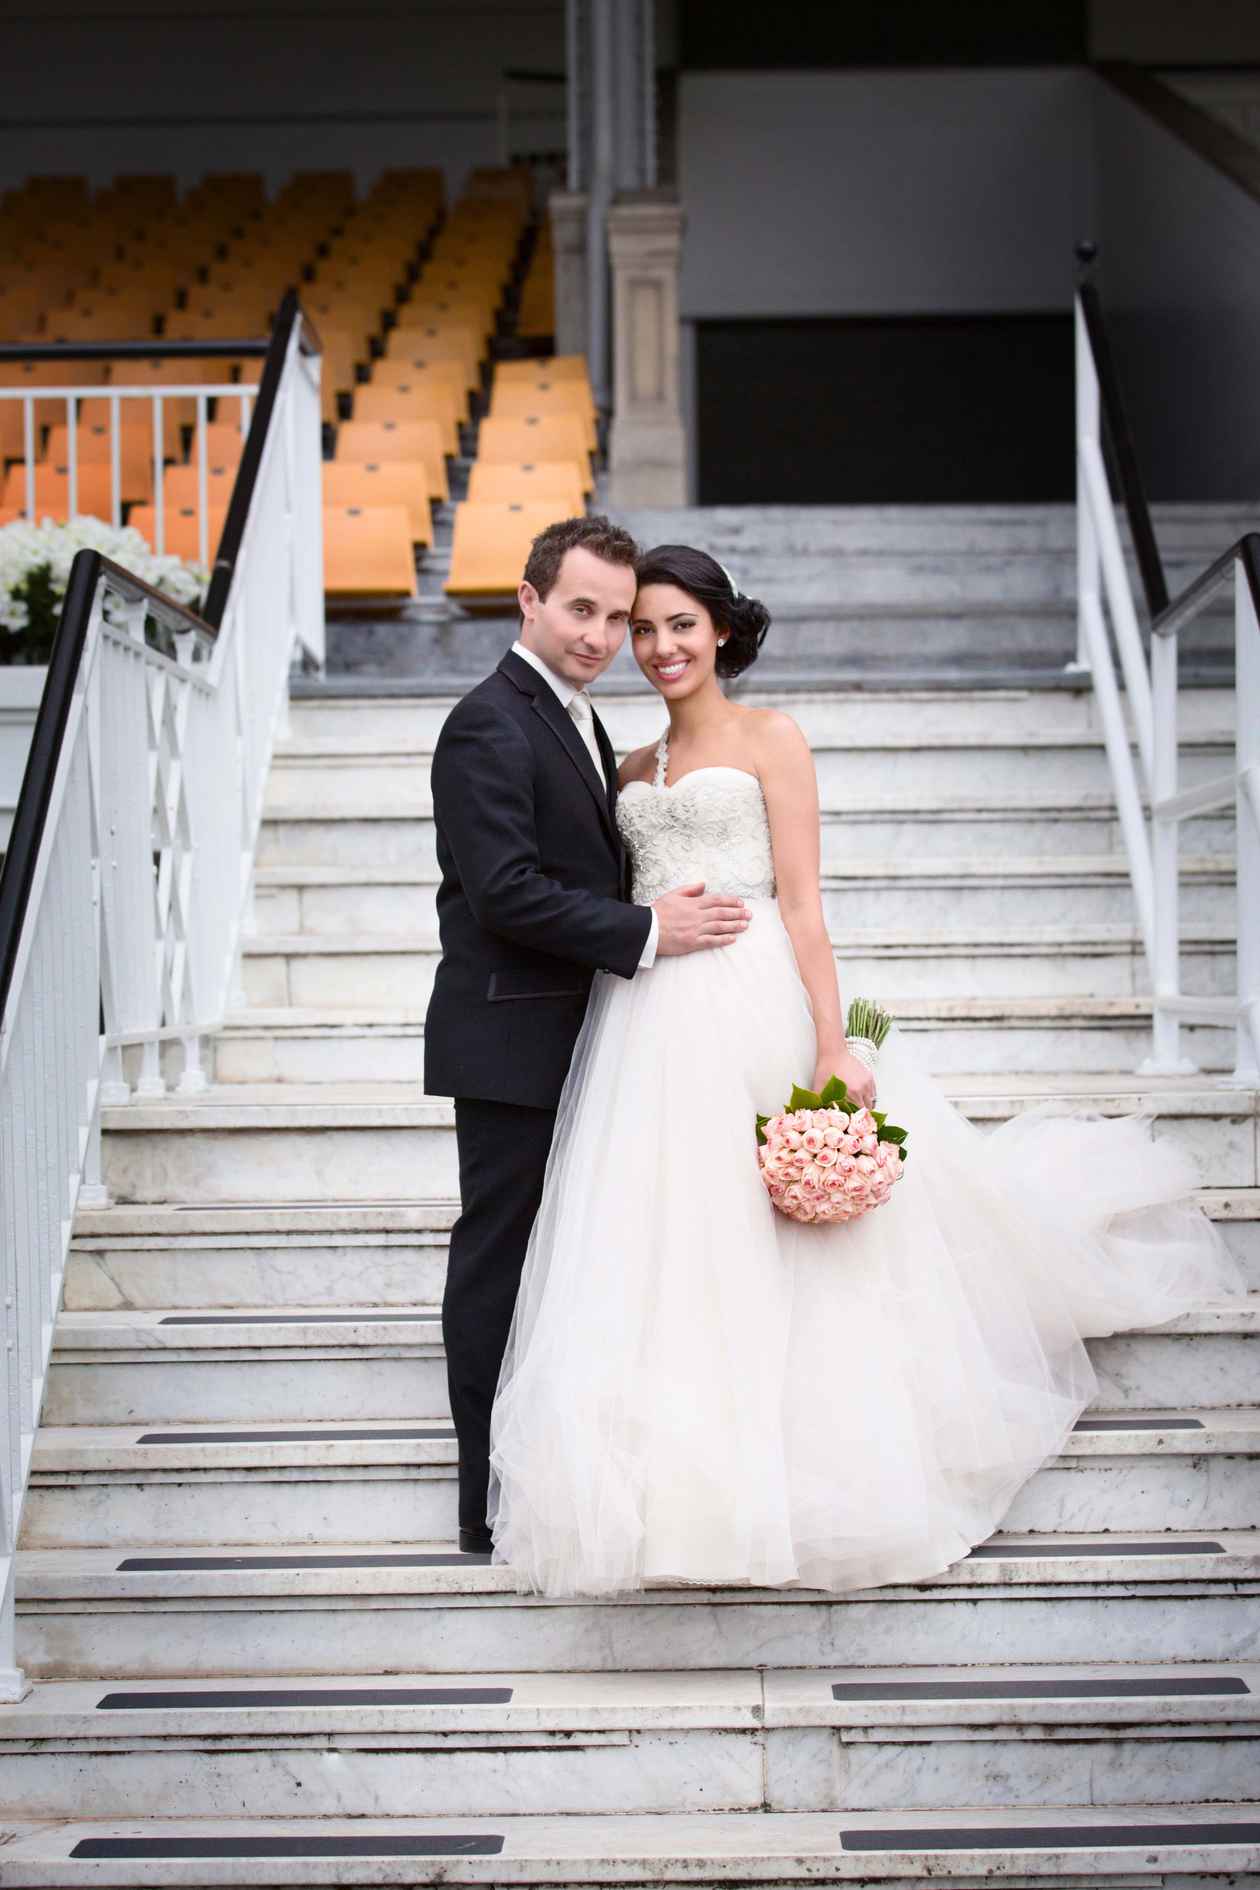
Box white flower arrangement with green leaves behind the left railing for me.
[0,518,208,663]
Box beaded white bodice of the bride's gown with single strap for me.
[618,735,775,905]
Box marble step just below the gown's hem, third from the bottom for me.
[17,1527,1260,1685]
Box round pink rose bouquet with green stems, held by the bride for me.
[758,1000,907,1221]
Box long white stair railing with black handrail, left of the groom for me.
[0,298,323,1699]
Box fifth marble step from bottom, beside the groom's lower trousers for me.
[43,1293,1260,1425]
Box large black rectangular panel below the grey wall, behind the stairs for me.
[695,310,1075,505]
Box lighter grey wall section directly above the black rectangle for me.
[678,68,1092,319]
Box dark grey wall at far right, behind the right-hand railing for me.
[1094,81,1260,501]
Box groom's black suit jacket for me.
[425,650,652,1109]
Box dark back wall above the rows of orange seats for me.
[0,0,565,201]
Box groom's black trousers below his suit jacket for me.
[442,1096,555,1529]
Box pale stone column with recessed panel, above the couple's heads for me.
[608,191,688,507]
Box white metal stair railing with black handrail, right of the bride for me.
[1077,279,1260,1087]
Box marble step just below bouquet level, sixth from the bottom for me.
[64,1189,1260,1315]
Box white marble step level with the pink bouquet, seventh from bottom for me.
[102,1074,1260,1208]
